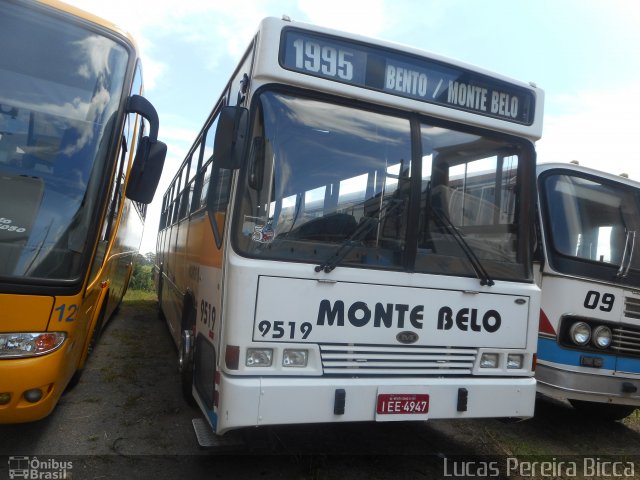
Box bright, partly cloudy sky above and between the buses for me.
[66,0,640,253]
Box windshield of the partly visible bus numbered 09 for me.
[542,172,640,280]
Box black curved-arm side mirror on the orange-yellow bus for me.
[126,95,167,204]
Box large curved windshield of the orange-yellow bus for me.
[0,5,129,281]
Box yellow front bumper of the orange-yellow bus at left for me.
[0,347,73,424]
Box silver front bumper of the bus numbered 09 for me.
[536,362,640,406]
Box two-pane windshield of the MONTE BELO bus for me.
[235,92,532,281]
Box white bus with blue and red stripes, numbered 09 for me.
[535,164,640,420]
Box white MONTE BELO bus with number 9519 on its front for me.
[157,18,543,440]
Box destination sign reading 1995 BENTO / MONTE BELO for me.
[280,28,535,125]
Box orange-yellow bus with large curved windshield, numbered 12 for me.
[0,0,166,423]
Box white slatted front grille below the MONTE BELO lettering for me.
[320,344,478,376]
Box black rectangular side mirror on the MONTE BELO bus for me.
[213,106,249,170]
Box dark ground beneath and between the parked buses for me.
[0,300,640,480]
